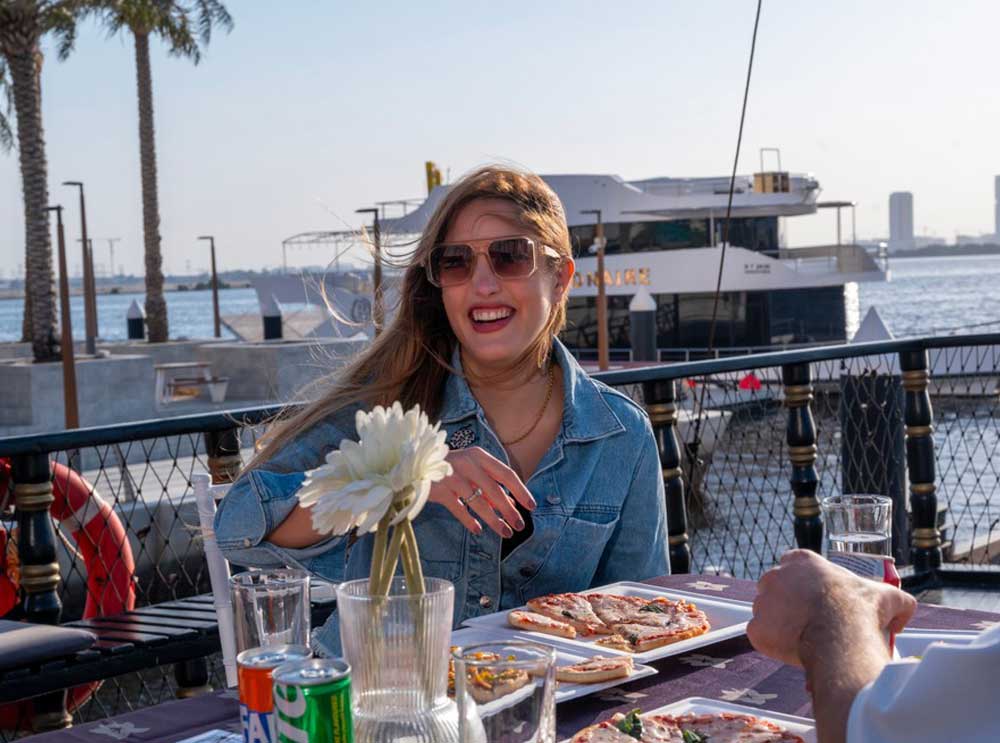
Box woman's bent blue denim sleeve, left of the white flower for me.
[215,423,346,568]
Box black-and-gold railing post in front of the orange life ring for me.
[11,454,73,731]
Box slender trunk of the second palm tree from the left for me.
[134,33,168,343]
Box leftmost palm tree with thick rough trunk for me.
[0,0,80,361]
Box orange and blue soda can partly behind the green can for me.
[236,645,312,743]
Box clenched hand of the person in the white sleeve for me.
[747,550,917,666]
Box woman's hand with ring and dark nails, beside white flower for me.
[429,446,535,537]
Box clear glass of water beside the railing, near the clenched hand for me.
[821,495,892,562]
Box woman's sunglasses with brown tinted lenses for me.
[426,237,560,287]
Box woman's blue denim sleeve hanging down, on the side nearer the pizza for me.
[594,418,670,586]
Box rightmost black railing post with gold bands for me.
[899,349,941,573]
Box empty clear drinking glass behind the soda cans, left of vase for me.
[229,568,309,652]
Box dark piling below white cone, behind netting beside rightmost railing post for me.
[840,371,910,565]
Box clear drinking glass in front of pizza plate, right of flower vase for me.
[453,641,556,743]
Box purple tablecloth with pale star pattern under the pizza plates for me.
[25,575,1000,743]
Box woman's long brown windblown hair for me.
[248,166,572,468]
